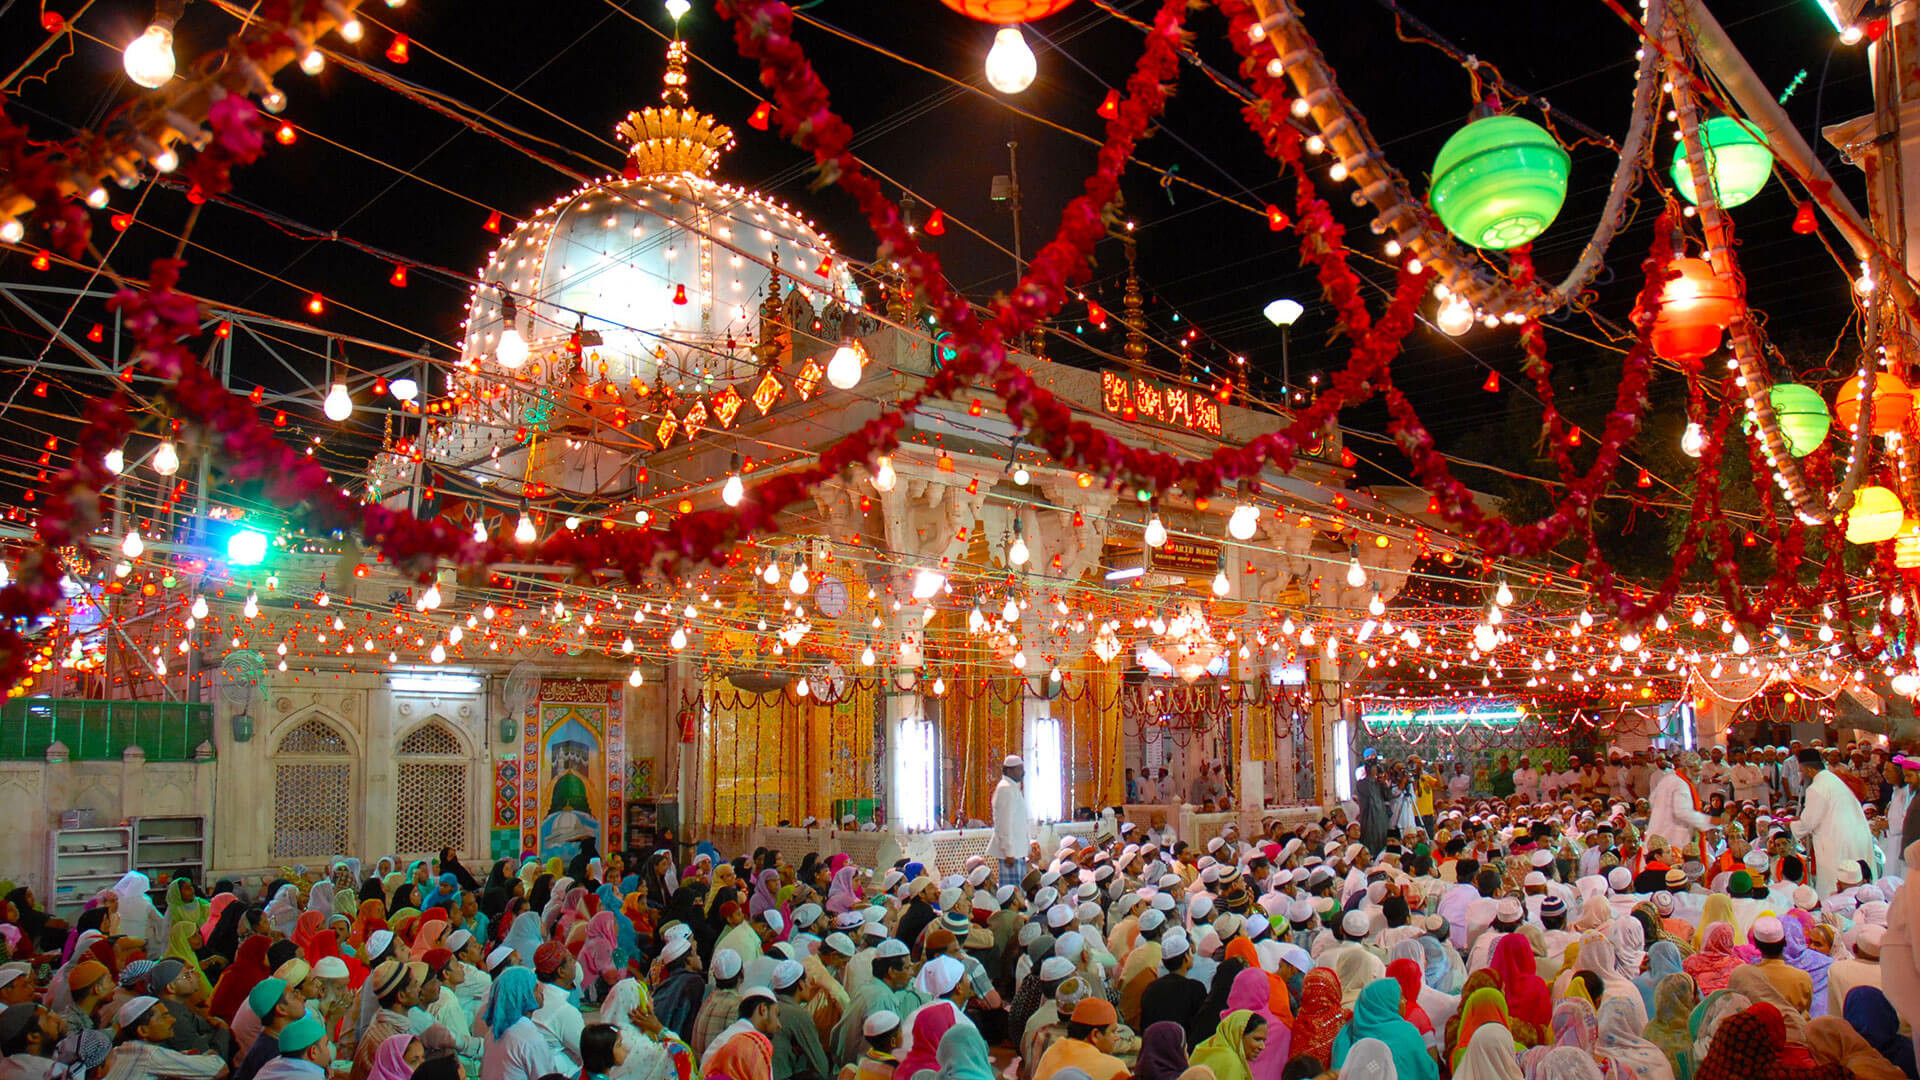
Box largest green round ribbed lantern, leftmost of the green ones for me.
[1432,115,1571,250]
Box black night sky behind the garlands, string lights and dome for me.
[0,0,1870,491]
